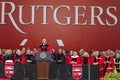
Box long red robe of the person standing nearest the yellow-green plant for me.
[103,56,114,76]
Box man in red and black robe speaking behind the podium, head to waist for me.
[38,39,52,52]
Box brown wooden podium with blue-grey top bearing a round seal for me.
[36,52,52,79]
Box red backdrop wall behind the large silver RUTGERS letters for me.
[0,0,120,51]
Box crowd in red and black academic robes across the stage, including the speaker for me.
[0,39,120,77]
